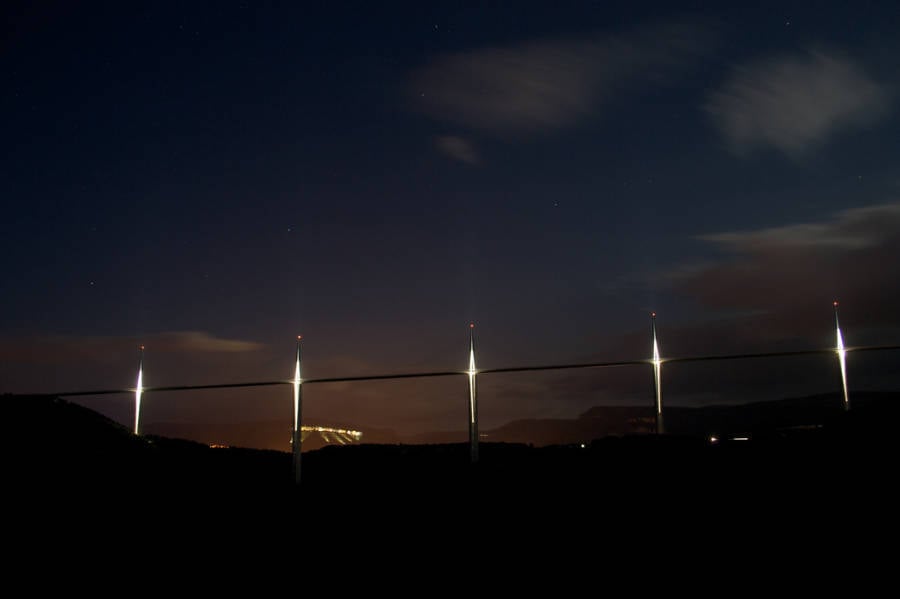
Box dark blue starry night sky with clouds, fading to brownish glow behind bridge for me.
[0,1,900,448]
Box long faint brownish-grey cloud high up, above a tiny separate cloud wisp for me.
[411,24,711,135]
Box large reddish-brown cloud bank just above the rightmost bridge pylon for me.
[671,202,900,346]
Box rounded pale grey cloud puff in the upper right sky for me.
[706,52,889,158]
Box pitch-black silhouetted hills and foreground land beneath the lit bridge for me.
[7,396,900,580]
